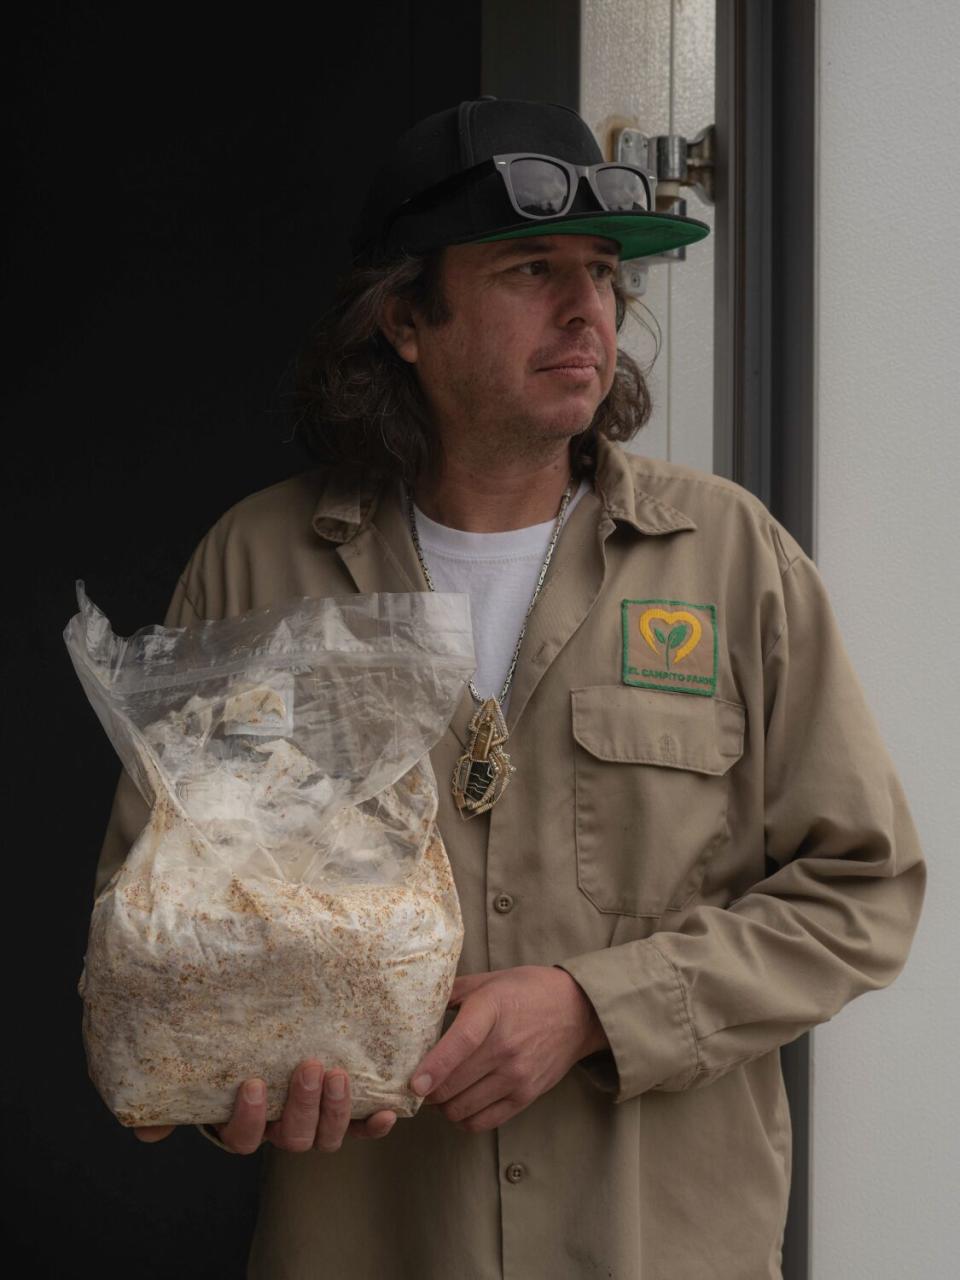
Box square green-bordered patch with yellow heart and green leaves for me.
[621,600,717,698]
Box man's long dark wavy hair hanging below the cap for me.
[293,250,652,484]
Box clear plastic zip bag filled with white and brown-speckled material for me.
[64,582,475,1125]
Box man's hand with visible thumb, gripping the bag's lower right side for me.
[411,965,608,1133]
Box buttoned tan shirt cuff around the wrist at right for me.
[558,938,700,1102]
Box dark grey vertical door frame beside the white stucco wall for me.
[714,0,817,1280]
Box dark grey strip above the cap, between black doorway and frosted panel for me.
[480,0,580,110]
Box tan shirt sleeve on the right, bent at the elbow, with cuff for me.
[561,553,925,1102]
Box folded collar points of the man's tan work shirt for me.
[312,436,696,543]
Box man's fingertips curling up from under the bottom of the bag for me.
[133,1060,397,1156]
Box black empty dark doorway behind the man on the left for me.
[4,0,480,1280]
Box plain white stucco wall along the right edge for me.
[813,0,960,1280]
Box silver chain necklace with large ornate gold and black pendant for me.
[406,480,573,818]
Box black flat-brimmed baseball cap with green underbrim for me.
[351,97,709,261]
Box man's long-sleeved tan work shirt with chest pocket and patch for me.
[101,442,924,1280]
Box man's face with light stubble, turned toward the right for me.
[398,236,618,456]
